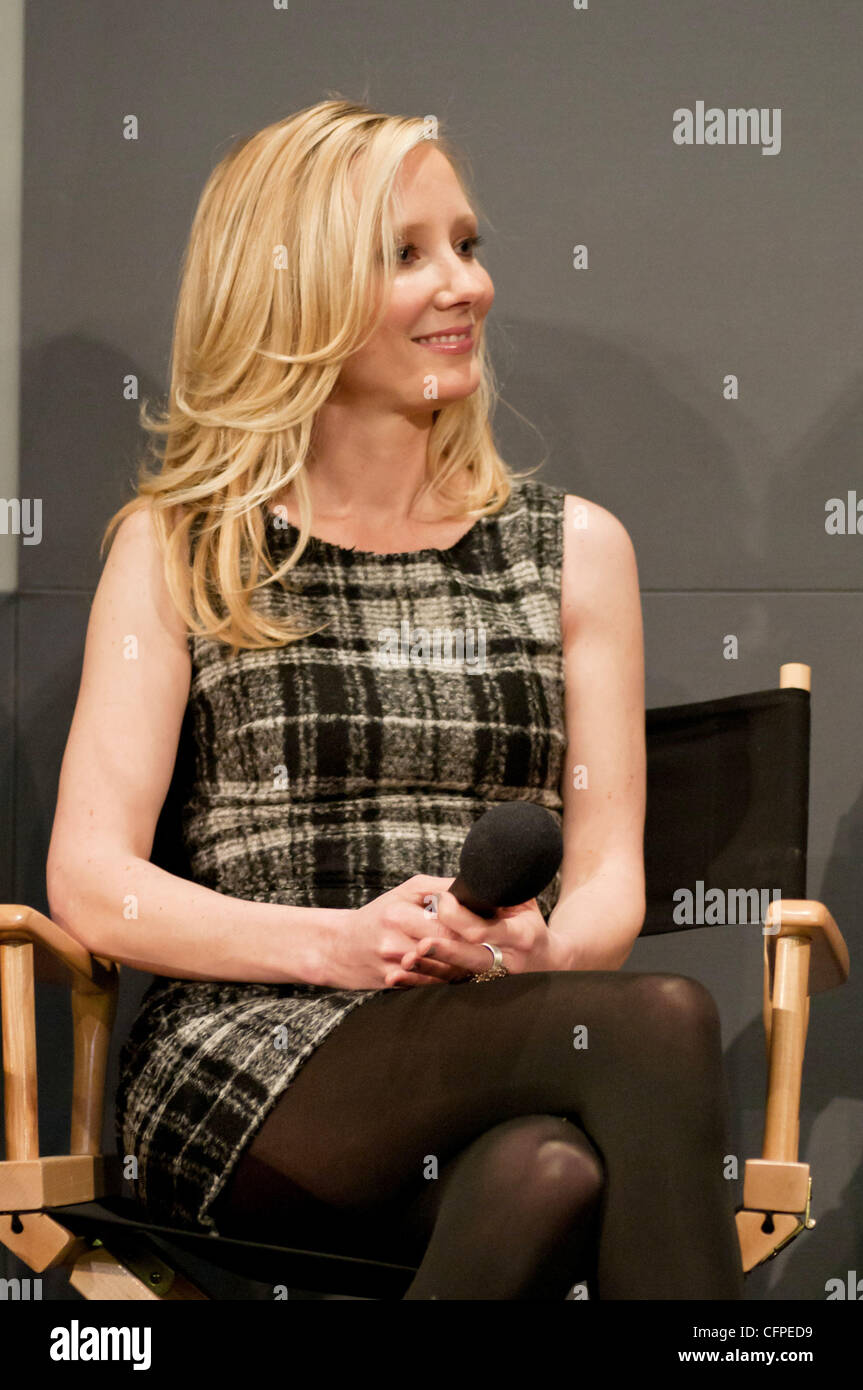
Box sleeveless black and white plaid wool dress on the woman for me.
[115,478,567,1233]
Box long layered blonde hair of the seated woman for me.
[100,99,536,653]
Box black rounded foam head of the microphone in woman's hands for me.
[449,801,563,917]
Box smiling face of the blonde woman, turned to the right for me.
[336,142,495,413]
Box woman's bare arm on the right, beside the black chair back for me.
[549,496,646,970]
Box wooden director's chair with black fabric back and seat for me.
[0,663,849,1300]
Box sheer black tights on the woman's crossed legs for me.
[213,970,743,1301]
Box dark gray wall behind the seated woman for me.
[0,0,863,1300]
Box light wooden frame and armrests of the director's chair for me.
[0,663,849,1300]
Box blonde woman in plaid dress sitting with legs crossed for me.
[49,100,742,1301]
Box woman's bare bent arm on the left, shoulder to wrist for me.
[47,509,336,984]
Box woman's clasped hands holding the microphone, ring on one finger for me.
[386,878,566,988]
